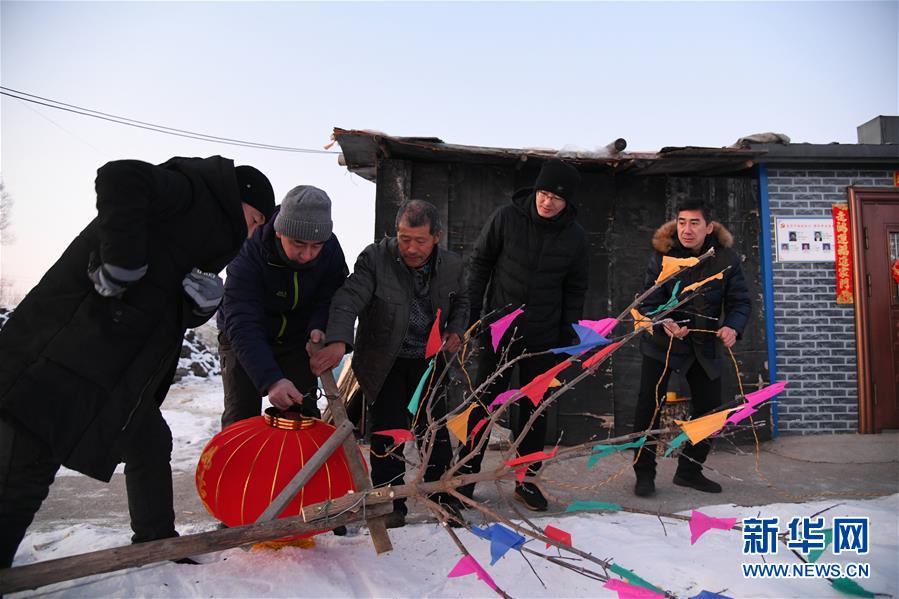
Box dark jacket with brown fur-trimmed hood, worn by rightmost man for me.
[640,221,751,380]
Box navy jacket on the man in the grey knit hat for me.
[218,209,349,395]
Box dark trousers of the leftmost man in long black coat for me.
[0,406,178,568]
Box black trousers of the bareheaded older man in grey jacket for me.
[371,358,452,513]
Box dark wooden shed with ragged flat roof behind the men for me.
[334,128,770,445]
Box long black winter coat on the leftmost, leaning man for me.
[0,156,247,481]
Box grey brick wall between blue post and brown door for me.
[768,167,892,434]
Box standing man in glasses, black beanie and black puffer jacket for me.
[460,159,588,511]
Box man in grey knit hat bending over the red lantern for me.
[218,185,349,428]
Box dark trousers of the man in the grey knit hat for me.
[219,333,321,428]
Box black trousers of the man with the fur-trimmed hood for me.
[634,356,721,476]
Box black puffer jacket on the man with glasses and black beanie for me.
[468,190,588,351]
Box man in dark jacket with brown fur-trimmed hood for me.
[634,199,750,497]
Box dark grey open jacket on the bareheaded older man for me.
[327,237,468,402]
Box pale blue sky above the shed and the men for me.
[0,1,899,300]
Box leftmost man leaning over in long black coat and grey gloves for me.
[0,156,274,568]
